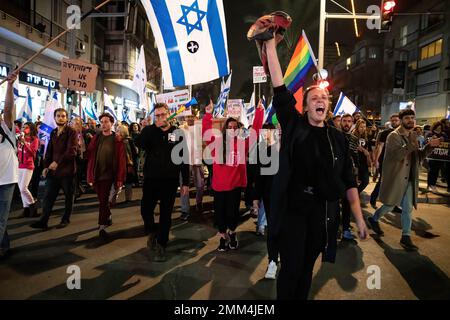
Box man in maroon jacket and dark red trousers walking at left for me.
[87,113,126,239]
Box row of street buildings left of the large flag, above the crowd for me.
[0,0,161,120]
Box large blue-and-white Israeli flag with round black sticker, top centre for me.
[141,0,230,88]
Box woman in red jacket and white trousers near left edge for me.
[17,122,39,217]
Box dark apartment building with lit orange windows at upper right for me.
[382,0,450,125]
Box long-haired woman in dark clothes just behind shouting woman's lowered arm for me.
[353,119,372,194]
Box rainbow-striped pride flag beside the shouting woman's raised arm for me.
[284,30,317,93]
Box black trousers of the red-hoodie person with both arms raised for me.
[214,188,241,233]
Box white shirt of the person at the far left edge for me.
[0,121,19,186]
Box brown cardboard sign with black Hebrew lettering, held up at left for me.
[60,59,98,92]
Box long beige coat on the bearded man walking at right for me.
[380,126,432,209]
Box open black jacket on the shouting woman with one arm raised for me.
[271,86,357,262]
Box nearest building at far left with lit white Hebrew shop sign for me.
[0,0,92,120]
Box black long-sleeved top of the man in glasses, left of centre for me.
[136,125,189,186]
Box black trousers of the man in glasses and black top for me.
[141,179,179,247]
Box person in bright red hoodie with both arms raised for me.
[202,102,264,251]
